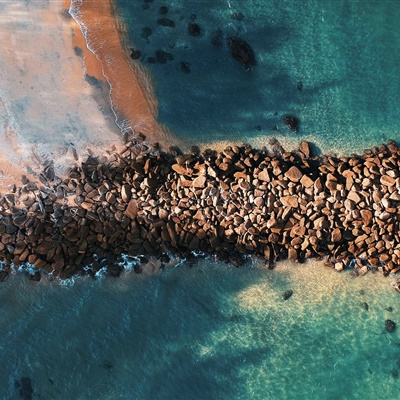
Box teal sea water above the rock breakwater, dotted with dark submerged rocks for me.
[114,0,400,153]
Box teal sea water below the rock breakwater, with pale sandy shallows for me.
[0,260,400,400]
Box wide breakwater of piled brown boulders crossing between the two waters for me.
[0,137,400,280]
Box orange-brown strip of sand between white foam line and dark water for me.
[69,0,173,148]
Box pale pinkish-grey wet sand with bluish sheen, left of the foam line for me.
[0,0,121,192]
